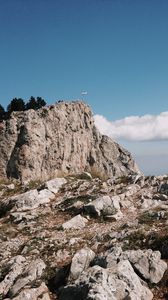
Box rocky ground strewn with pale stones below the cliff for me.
[0,173,168,300]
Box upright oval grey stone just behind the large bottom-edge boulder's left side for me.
[69,248,95,280]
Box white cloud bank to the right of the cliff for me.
[94,111,168,141]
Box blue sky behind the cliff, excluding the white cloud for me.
[0,0,168,173]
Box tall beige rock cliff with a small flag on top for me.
[0,101,138,181]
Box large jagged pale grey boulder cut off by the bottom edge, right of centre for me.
[59,260,153,300]
